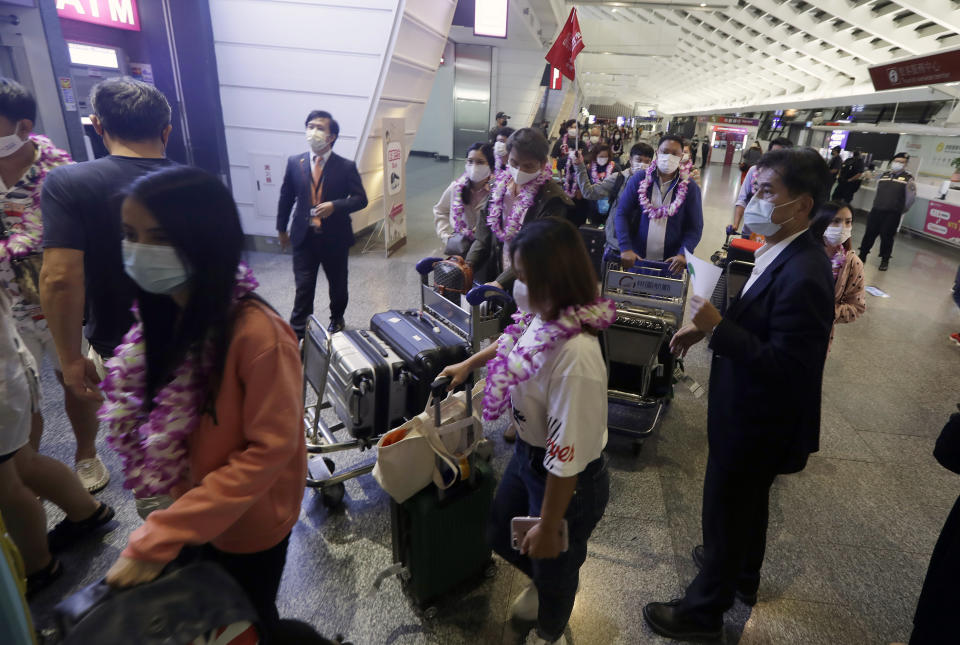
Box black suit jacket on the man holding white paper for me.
[707,232,834,473]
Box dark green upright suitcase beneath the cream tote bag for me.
[390,459,496,607]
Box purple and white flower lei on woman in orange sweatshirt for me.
[99,262,258,497]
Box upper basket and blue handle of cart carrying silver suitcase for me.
[417,258,513,354]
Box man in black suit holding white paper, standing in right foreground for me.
[643,148,833,640]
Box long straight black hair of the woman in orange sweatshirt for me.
[127,166,243,407]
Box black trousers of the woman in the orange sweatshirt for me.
[177,533,290,643]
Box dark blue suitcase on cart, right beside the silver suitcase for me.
[370,309,470,417]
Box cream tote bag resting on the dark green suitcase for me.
[373,381,484,503]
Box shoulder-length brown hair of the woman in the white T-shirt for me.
[510,217,597,328]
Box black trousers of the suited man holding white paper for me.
[682,456,777,623]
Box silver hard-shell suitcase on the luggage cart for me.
[327,330,410,438]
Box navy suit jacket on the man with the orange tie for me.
[277,152,367,249]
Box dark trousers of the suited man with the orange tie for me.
[290,231,350,338]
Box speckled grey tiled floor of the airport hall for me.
[26,153,960,645]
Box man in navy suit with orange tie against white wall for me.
[277,110,367,338]
